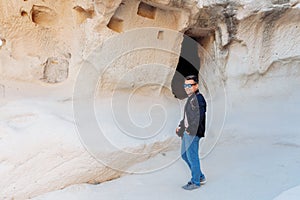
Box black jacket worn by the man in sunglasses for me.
[179,90,206,138]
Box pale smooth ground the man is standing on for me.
[34,119,300,200]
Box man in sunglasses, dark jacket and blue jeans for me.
[176,75,206,190]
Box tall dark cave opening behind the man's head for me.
[171,34,201,99]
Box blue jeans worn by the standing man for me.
[181,132,205,186]
